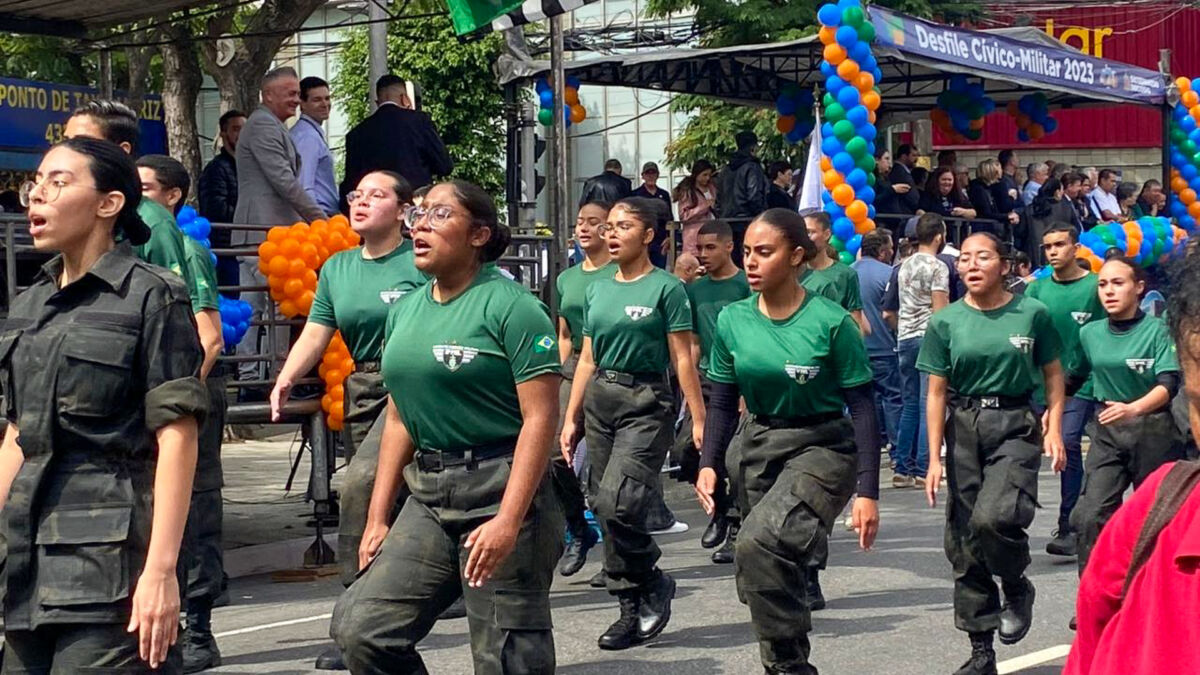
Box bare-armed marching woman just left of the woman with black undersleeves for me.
[560,197,704,650]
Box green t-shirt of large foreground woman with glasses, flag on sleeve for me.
[382,268,559,450]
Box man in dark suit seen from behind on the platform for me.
[338,74,454,210]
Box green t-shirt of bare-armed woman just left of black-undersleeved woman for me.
[583,268,691,374]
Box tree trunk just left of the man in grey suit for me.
[161,30,204,204]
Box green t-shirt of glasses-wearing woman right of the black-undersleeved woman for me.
[917,295,1062,398]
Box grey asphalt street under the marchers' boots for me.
[201,458,1076,675]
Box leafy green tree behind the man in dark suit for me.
[332,16,505,195]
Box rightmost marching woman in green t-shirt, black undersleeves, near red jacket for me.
[1068,258,1183,575]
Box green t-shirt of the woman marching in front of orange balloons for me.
[308,241,427,363]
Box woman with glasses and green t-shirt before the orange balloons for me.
[271,171,426,586]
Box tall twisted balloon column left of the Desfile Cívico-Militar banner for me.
[817,0,882,264]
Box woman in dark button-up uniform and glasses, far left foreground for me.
[0,138,208,673]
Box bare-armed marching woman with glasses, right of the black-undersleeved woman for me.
[917,232,1067,675]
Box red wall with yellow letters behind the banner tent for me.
[934,0,1200,148]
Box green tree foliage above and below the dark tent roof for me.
[646,0,982,169]
